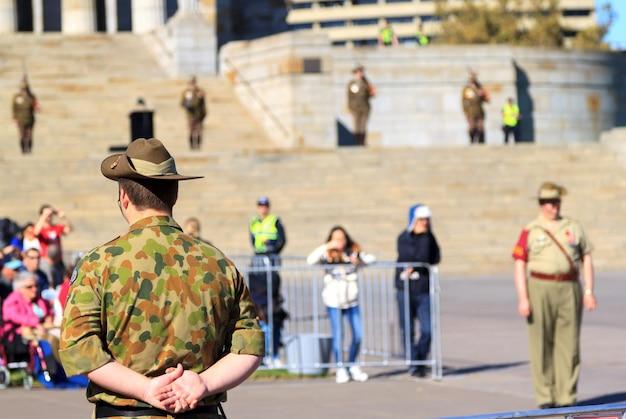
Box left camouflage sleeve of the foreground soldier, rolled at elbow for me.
[59,253,112,376]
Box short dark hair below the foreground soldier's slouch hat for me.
[119,179,178,212]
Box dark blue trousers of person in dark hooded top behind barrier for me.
[396,290,431,361]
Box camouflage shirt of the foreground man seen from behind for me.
[59,217,265,406]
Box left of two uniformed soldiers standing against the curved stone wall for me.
[348,66,376,145]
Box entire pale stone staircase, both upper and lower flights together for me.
[0,35,626,275]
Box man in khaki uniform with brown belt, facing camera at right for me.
[513,182,596,408]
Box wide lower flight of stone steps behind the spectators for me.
[0,145,626,274]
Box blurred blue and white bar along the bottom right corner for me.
[442,403,626,419]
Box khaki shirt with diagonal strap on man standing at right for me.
[513,216,593,275]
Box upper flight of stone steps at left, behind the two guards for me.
[0,34,269,158]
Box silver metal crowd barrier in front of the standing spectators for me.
[227,256,443,379]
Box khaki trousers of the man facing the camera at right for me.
[528,278,582,406]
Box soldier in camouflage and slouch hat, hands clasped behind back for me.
[60,139,264,419]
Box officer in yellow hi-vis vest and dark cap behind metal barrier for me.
[250,196,287,367]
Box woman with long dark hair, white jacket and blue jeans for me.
[307,226,374,384]
